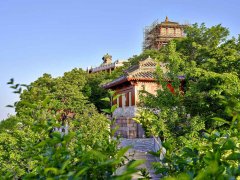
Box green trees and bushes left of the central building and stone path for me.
[0,69,140,179]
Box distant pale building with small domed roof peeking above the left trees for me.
[87,54,124,73]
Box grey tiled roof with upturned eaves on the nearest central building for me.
[103,57,165,89]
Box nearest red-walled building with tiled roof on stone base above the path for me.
[103,57,169,138]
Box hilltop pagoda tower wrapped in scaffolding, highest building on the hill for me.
[143,17,187,50]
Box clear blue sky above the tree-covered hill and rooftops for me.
[0,0,240,120]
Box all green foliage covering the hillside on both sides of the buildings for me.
[0,24,240,179]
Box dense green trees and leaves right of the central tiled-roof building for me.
[132,24,240,179]
